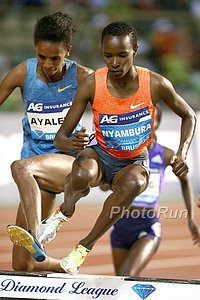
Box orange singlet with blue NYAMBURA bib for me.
[92,67,155,159]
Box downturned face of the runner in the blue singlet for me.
[35,41,70,76]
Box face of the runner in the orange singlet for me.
[102,35,135,78]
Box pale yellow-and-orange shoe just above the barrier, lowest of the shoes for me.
[60,244,90,275]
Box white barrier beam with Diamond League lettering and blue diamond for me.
[0,271,200,300]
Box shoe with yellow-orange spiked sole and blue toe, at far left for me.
[6,225,46,262]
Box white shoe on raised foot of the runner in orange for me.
[37,206,69,244]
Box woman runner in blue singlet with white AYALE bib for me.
[0,12,93,271]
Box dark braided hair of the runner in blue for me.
[33,12,78,48]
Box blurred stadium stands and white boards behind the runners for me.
[0,0,200,206]
